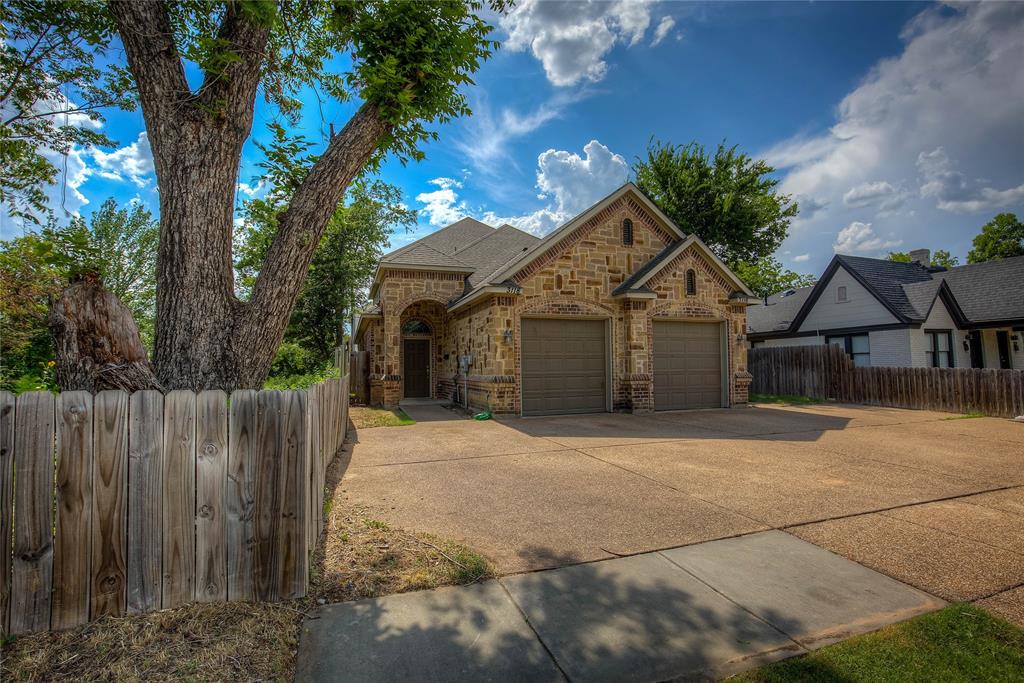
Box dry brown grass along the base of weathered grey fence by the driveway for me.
[0,446,494,682]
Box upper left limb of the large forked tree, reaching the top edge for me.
[110,0,191,137]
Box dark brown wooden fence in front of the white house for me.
[746,345,1024,418]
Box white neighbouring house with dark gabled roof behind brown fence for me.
[746,249,1024,369]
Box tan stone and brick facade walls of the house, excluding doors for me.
[356,184,750,414]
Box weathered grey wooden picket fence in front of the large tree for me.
[0,377,348,634]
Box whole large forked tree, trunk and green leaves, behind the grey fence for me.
[3,0,505,389]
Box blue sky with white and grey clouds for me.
[8,0,1024,272]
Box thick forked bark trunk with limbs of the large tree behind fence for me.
[111,0,390,390]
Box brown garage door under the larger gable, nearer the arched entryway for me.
[522,318,607,415]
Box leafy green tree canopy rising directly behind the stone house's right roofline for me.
[633,140,799,266]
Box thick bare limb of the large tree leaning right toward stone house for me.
[240,103,391,378]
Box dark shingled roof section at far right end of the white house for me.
[935,256,1024,323]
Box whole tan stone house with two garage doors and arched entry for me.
[354,183,752,415]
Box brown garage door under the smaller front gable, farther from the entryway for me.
[654,321,722,411]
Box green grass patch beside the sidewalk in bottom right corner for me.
[730,604,1024,683]
